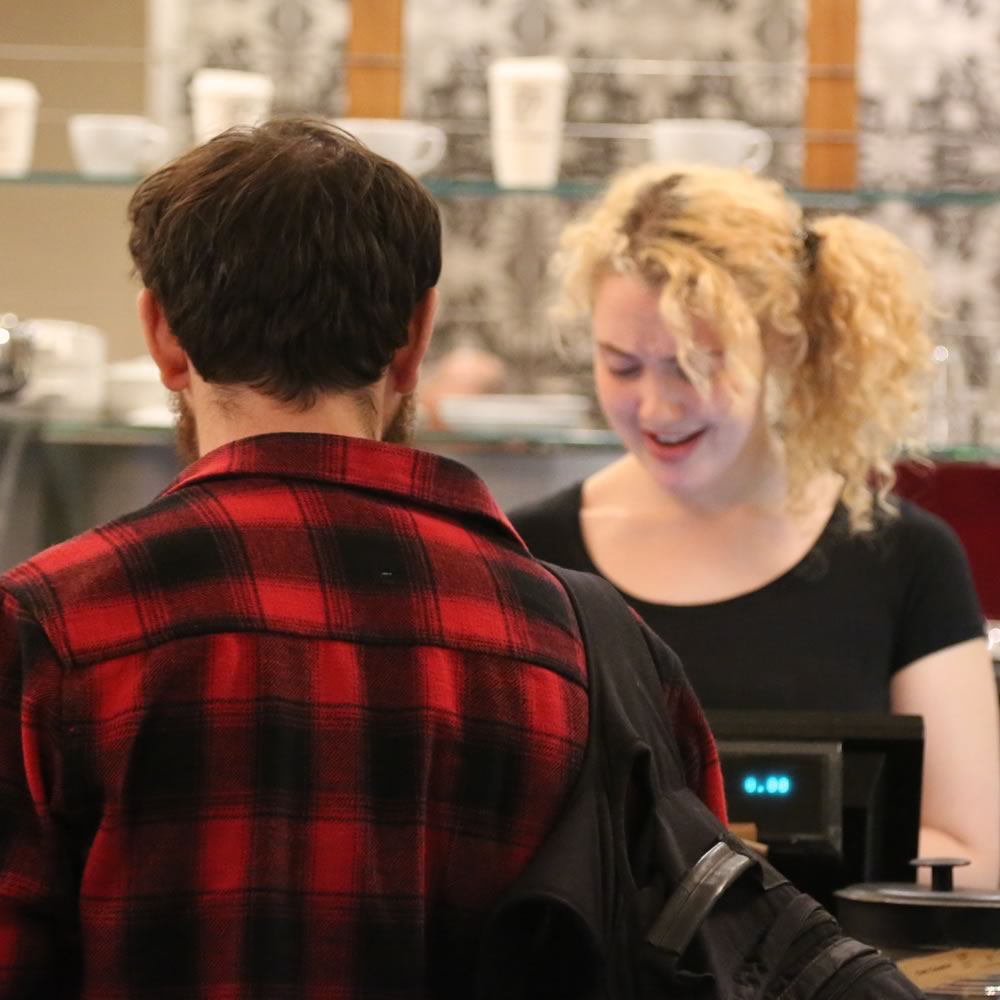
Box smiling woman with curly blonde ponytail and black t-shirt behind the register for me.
[512,164,1000,886]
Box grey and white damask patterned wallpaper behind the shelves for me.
[161,0,1000,443]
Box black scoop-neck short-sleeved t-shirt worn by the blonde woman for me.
[510,483,983,712]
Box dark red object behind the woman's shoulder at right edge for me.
[895,462,1000,619]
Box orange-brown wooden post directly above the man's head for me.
[347,0,404,118]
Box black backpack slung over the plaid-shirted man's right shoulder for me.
[477,566,923,1000]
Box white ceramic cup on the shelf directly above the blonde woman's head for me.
[649,118,774,173]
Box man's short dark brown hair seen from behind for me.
[129,119,441,406]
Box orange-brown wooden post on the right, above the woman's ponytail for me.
[802,0,859,189]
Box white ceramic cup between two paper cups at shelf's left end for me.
[67,115,167,177]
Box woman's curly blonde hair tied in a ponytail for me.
[557,163,932,531]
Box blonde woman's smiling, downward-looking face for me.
[592,274,768,502]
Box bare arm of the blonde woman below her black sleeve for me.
[890,639,1000,888]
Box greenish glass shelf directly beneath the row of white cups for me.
[0,171,1000,210]
